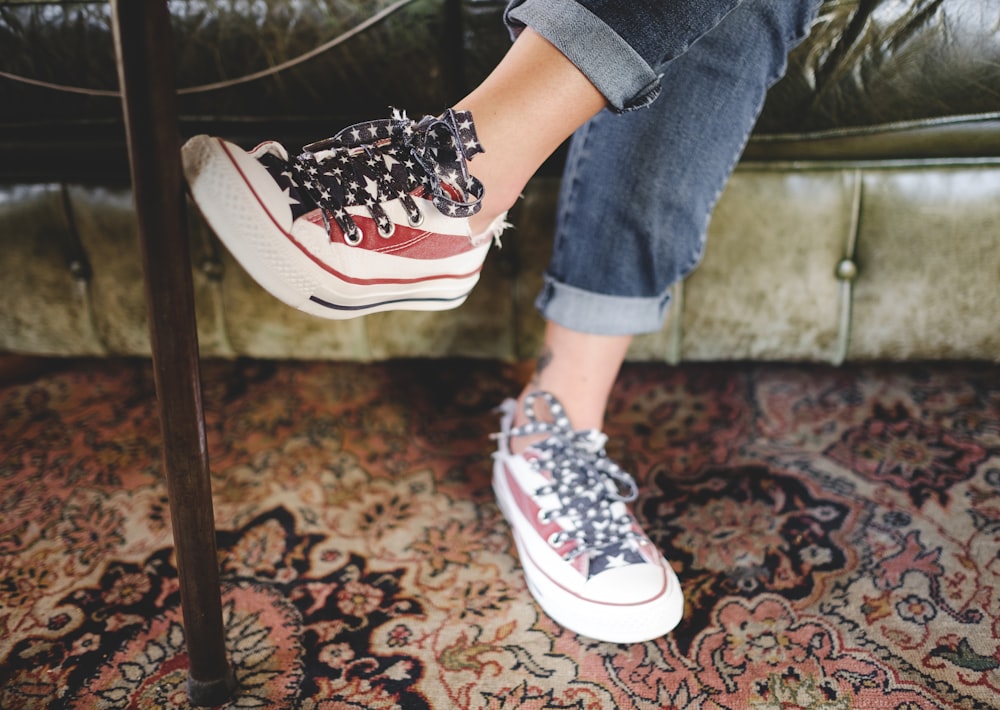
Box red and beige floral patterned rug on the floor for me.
[0,361,1000,710]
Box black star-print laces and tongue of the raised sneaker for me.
[289,109,483,245]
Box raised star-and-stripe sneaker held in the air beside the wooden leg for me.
[181,110,506,319]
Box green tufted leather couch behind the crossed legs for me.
[0,0,1000,363]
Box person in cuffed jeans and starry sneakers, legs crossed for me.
[182,0,819,643]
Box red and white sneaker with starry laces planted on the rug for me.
[493,392,684,643]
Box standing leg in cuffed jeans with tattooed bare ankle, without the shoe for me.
[522,0,815,426]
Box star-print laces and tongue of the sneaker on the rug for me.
[506,392,646,560]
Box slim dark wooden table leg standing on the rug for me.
[111,0,236,705]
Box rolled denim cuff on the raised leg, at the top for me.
[504,0,660,113]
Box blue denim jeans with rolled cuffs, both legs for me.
[507,0,819,335]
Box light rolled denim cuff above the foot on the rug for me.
[535,274,670,335]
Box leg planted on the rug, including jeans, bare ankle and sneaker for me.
[494,0,814,642]
